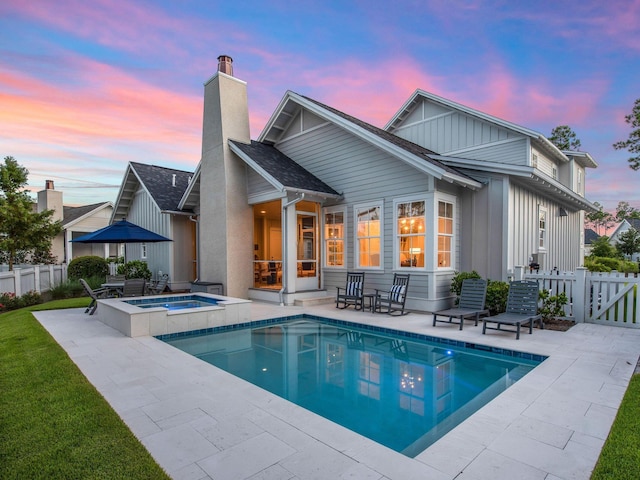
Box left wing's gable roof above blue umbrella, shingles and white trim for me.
[111,162,193,219]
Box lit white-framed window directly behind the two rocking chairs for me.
[355,206,382,268]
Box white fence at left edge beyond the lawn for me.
[0,265,67,297]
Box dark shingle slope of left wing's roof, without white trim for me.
[131,162,193,210]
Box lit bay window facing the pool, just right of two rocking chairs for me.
[396,201,426,268]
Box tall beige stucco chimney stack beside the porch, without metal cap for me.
[198,73,253,298]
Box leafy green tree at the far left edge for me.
[0,157,62,270]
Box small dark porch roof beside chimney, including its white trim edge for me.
[229,140,340,197]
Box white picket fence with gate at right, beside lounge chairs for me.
[514,267,640,328]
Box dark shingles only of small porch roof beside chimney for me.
[230,140,339,195]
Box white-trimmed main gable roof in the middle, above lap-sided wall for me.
[258,91,482,189]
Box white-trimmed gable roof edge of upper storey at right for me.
[384,89,597,167]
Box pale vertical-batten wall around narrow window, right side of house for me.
[508,183,584,271]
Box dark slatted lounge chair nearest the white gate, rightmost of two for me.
[482,280,544,340]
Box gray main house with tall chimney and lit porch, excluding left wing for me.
[116,55,596,311]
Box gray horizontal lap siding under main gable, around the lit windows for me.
[276,120,476,310]
